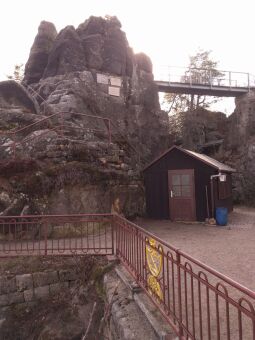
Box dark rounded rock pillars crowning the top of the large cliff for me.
[24,17,135,84]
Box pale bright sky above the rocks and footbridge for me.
[0,0,255,111]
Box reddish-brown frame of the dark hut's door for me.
[167,169,197,221]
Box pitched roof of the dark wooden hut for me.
[143,145,236,172]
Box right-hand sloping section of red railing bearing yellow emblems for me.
[114,216,255,340]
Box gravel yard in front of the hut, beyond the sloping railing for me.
[136,206,255,291]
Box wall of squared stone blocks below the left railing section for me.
[0,269,78,308]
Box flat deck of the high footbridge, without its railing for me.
[155,80,252,97]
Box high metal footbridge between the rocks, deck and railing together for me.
[154,66,255,97]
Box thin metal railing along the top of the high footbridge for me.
[154,66,255,89]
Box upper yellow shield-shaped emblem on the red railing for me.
[145,238,163,277]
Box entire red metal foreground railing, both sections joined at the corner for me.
[0,214,255,340]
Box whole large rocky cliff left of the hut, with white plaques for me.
[0,17,168,216]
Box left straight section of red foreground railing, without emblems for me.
[0,214,113,257]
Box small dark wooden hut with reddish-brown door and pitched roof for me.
[144,146,235,221]
